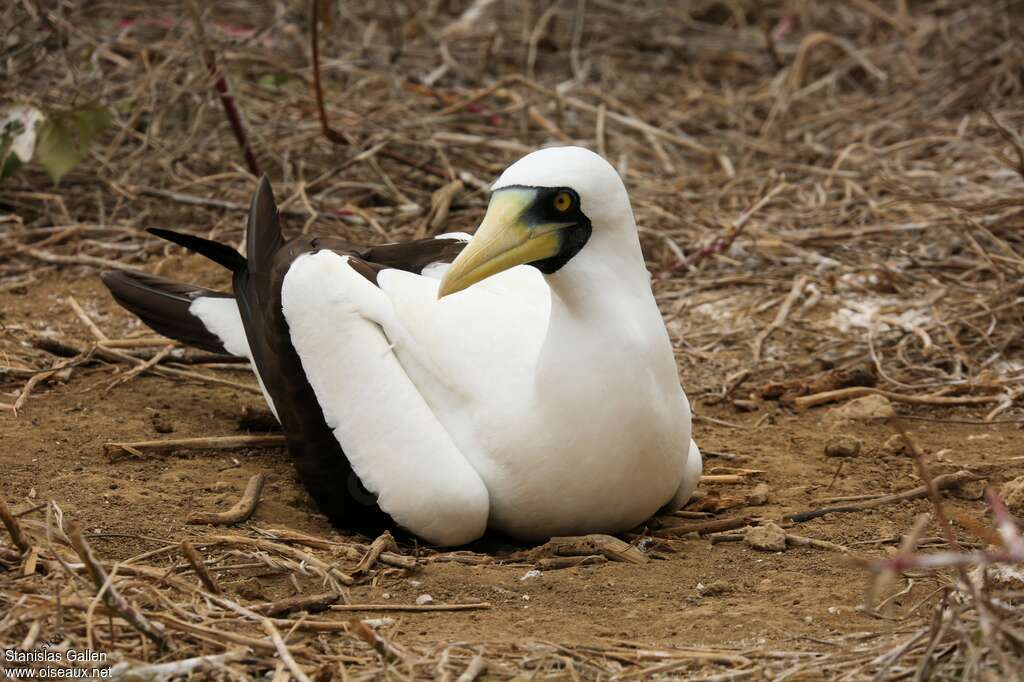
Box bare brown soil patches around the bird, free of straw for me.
[0,263,1024,667]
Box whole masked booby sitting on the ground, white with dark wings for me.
[103,146,701,546]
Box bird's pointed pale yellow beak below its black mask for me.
[437,187,572,298]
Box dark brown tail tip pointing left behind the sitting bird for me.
[100,270,232,354]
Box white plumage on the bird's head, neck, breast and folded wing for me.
[283,147,700,545]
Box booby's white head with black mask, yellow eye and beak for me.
[437,146,635,298]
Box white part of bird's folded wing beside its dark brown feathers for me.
[281,249,488,545]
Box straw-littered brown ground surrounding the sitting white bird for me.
[0,0,1024,680]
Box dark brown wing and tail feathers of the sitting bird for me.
[103,177,465,534]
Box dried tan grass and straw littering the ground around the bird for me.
[0,0,1024,679]
